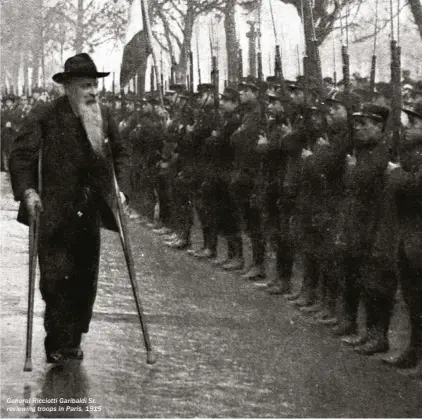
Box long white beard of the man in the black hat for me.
[78,102,105,157]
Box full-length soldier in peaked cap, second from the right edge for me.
[335,104,389,354]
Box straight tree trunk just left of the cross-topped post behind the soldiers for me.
[224,0,239,84]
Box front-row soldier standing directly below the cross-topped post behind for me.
[229,78,266,280]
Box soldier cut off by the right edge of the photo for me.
[380,104,422,368]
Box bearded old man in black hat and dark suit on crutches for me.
[10,54,129,363]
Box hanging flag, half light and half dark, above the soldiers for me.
[120,2,151,86]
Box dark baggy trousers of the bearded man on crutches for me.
[39,209,100,349]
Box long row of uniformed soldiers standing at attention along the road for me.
[114,56,422,378]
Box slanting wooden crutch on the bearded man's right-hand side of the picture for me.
[110,161,157,364]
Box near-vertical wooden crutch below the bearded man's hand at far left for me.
[23,211,40,371]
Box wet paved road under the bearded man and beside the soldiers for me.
[0,174,422,417]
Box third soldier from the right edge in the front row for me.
[302,93,359,325]
